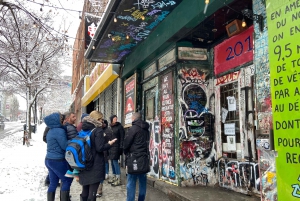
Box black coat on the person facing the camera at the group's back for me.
[107,122,125,160]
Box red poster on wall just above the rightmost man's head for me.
[124,74,136,128]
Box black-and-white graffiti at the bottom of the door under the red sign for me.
[218,158,260,194]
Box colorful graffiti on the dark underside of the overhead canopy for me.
[95,0,182,63]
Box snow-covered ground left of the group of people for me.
[0,124,48,201]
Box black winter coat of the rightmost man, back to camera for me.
[123,119,149,155]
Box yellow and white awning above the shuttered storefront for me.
[81,64,119,107]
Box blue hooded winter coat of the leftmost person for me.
[44,113,68,159]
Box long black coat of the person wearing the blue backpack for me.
[79,122,111,186]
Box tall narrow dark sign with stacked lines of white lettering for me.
[161,72,176,182]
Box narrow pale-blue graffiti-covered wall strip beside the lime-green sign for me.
[253,0,277,201]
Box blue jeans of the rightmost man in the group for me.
[127,174,147,201]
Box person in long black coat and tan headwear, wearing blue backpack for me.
[79,111,116,201]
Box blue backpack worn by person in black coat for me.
[65,129,94,170]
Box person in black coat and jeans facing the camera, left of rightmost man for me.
[108,115,125,186]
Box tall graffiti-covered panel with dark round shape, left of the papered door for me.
[177,66,217,186]
